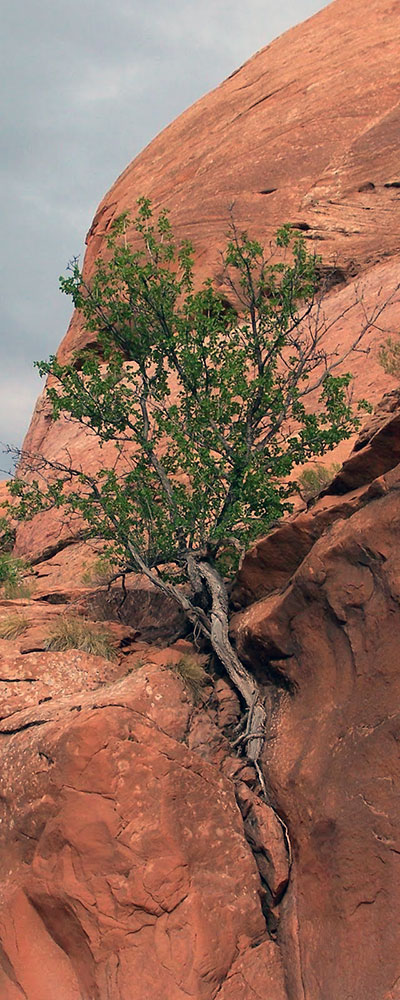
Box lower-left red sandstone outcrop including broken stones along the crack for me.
[0,602,289,1000]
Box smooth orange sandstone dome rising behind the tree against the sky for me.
[18,0,400,557]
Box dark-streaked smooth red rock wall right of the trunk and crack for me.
[234,410,400,1000]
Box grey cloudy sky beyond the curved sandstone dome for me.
[0,0,328,478]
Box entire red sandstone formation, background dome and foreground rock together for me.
[0,0,400,1000]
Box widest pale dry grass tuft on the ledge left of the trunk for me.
[45,615,117,660]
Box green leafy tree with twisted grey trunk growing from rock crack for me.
[11,198,376,781]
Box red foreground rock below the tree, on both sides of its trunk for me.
[0,392,400,1000]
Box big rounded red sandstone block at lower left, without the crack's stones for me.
[0,667,276,1000]
